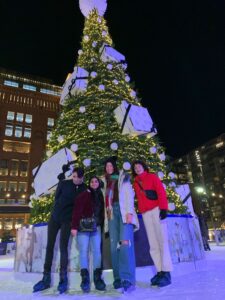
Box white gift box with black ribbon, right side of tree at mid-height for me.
[114,100,157,137]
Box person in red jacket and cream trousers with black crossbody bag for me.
[132,160,172,287]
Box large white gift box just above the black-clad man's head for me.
[32,148,76,197]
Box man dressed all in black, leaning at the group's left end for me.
[33,168,86,293]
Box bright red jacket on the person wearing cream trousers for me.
[133,171,168,213]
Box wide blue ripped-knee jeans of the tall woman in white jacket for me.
[109,203,136,284]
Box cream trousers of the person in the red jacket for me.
[142,207,172,272]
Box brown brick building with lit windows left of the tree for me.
[0,69,61,238]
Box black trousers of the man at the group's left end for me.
[44,218,71,273]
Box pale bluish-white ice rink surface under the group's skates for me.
[0,246,225,300]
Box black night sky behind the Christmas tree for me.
[0,0,225,157]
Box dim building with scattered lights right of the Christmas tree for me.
[171,133,225,228]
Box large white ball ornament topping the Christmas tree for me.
[79,0,107,17]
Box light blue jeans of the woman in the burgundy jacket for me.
[77,226,102,270]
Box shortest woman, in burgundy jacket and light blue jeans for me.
[71,176,106,292]
